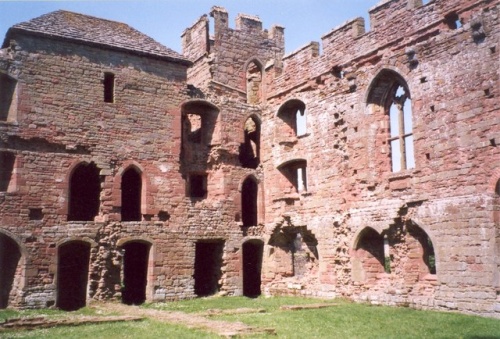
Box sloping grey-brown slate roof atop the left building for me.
[3,10,191,64]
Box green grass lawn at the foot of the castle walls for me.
[0,297,500,339]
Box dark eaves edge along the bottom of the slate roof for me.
[2,27,193,67]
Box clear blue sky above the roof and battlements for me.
[0,0,381,53]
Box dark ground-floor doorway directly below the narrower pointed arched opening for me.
[122,242,151,305]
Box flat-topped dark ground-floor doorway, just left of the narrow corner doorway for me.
[194,241,224,297]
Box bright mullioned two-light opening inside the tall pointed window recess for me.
[389,84,415,172]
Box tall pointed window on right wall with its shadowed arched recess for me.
[368,70,415,172]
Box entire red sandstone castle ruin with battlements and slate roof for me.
[0,0,500,318]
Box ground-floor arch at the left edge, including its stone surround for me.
[0,229,27,309]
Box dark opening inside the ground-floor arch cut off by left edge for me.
[0,233,21,309]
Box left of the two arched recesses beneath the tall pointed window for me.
[351,226,385,282]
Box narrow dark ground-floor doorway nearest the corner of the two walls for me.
[243,240,264,298]
